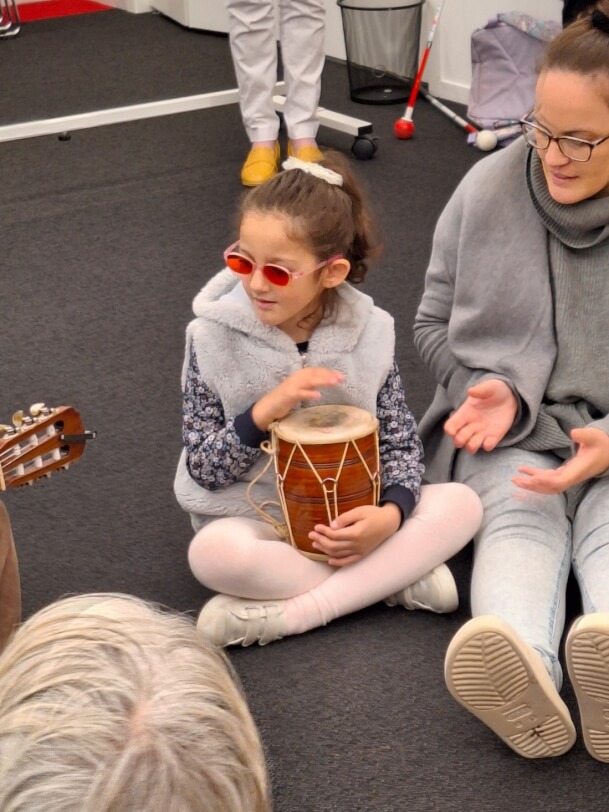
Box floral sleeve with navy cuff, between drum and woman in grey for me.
[376,362,425,519]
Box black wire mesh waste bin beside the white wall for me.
[337,0,425,104]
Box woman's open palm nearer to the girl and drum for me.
[444,378,518,454]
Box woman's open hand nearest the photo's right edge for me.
[512,428,609,493]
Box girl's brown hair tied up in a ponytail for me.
[239,152,381,284]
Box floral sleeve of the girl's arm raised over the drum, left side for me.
[182,347,262,491]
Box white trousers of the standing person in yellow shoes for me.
[226,0,325,141]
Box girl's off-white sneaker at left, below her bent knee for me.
[197,595,285,647]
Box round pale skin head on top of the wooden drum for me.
[275,404,378,445]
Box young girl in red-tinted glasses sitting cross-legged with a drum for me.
[175,155,481,646]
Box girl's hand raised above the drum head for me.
[252,367,345,431]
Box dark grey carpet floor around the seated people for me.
[0,11,607,812]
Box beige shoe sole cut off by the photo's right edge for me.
[565,613,609,762]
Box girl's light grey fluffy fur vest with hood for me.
[174,270,395,528]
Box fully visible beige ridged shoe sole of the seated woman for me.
[445,617,575,758]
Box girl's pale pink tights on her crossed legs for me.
[188,483,482,634]
